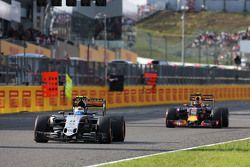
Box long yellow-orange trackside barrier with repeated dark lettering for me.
[0,85,250,114]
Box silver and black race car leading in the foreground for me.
[34,96,126,143]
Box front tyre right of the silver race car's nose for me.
[98,116,112,144]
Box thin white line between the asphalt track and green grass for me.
[86,137,250,167]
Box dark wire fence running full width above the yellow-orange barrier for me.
[0,56,250,86]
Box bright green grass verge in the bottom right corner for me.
[100,140,250,167]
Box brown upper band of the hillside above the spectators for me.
[137,11,250,36]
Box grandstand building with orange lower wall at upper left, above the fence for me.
[0,0,137,62]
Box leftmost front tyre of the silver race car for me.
[34,115,50,143]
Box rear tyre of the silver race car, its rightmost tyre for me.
[111,116,126,142]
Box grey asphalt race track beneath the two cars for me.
[0,101,250,167]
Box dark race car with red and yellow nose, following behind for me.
[165,93,229,128]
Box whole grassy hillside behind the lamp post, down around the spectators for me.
[136,11,250,65]
